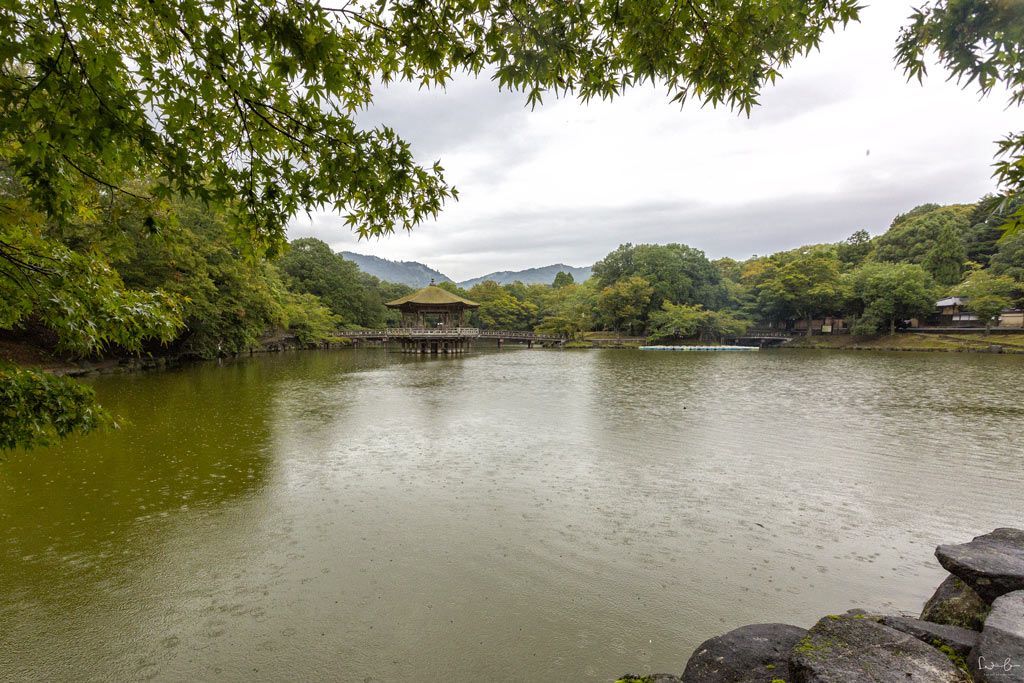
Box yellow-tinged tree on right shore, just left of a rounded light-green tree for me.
[758,251,843,335]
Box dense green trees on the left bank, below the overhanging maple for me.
[0,169,411,358]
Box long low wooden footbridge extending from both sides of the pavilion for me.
[337,327,568,353]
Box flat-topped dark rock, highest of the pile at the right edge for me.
[935,528,1024,603]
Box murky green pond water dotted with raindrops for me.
[0,349,1024,681]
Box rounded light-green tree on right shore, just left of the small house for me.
[848,262,936,334]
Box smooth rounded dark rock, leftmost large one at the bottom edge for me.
[682,624,807,683]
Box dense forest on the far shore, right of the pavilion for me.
[432,197,1024,340]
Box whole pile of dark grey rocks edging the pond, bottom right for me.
[620,528,1024,683]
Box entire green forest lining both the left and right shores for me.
[3,185,1024,358]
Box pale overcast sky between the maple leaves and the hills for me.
[289,0,1020,280]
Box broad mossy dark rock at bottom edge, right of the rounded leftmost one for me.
[785,615,968,683]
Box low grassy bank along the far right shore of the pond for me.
[784,332,1024,353]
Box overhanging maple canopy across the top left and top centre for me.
[0,0,858,262]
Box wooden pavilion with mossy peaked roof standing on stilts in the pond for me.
[384,280,480,353]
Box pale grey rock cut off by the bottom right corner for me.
[968,591,1024,683]
